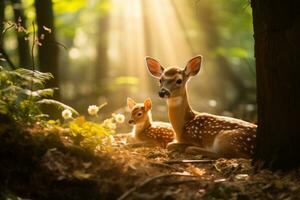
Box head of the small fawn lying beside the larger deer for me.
[127,98,152,125]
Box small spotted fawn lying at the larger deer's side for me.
[127,98,174,148]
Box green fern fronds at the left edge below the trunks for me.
[0,67,77,125]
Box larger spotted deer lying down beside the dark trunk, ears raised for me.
[146,55,257,158]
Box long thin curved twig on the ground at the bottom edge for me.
[118,173,196,200]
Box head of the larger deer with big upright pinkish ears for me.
[146,55,202,98]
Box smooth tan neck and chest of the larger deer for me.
[167,90,195,141]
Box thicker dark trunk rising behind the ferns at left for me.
[35,0,59,99]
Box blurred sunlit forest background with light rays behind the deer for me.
[0,0,256,130]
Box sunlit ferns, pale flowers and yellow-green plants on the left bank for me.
[0,19,124,152]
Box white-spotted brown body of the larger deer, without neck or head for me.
[180,113,257,157]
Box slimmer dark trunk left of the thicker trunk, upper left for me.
[10,0,31,68]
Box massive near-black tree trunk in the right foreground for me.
[251,0,300,169]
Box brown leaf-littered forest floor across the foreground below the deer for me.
[0,124,300,200]
